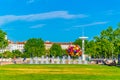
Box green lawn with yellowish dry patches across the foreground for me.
[0,64,120,80]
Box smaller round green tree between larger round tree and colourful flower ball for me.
[50,43,62,57]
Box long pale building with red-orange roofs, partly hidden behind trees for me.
[0,41,73,53]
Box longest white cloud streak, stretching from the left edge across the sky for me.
[0,11,88,25]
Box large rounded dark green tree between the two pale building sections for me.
[24,38,45,57]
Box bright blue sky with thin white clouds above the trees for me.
[0,0,120,42]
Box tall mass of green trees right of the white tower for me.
[86,26,120,58]
